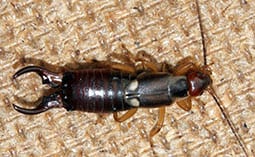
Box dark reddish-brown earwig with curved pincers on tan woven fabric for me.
[13,0,248,156]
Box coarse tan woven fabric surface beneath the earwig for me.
[0,0,255,156]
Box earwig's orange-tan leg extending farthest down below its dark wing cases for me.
[149,107,166,146]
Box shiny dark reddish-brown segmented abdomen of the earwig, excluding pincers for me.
[62,69,130,112]
